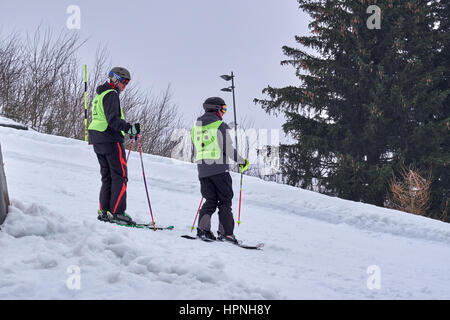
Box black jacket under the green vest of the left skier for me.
[88,82,131,144]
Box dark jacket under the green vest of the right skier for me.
[194,112,245,179]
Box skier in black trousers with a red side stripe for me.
[88,67,141,224]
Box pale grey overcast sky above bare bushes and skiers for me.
[0,0,309,140]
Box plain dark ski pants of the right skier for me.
[198,172,234,235]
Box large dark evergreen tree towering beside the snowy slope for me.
[255,0,449,216]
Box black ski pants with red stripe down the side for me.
[94,142,128,213]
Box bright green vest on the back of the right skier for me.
[191,120,222,161]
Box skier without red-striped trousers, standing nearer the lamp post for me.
[191,97,249,243]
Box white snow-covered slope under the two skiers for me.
[0,127,450,300]
